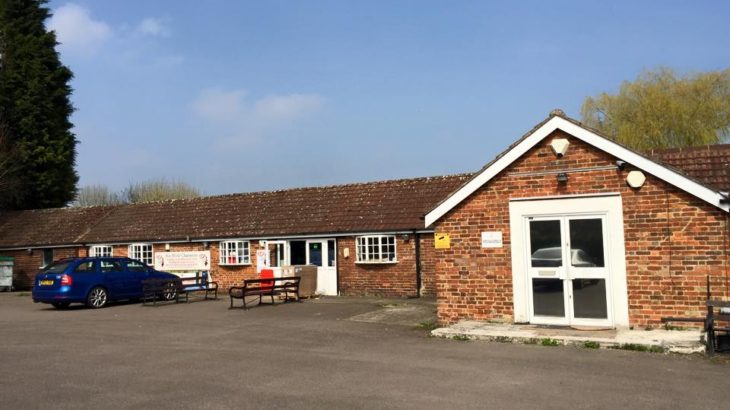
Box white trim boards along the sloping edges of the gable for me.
[425,116,730,227]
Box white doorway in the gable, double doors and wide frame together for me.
[510,196,628,327]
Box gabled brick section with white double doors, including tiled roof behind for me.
[425,111,730,327]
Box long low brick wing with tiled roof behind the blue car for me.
[0,174,470,296]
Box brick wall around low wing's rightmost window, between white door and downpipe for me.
[337,234,417,297]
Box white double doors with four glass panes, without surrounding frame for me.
[525,214,613,326]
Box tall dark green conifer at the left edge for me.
[0,0,78,209]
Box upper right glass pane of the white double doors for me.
[569,218,605,268]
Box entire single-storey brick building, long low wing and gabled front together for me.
[0,111,730,327]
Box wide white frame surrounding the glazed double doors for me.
[509,194,629,327]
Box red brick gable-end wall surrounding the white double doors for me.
[435,131,730,326]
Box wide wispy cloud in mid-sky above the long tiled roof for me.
[192,88,325,148]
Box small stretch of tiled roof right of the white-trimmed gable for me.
[648,144,730,191]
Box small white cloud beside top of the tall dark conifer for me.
[48,3,113,55]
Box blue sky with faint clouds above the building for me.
[46,0,730,195]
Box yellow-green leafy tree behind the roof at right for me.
[581,68,730,151]
